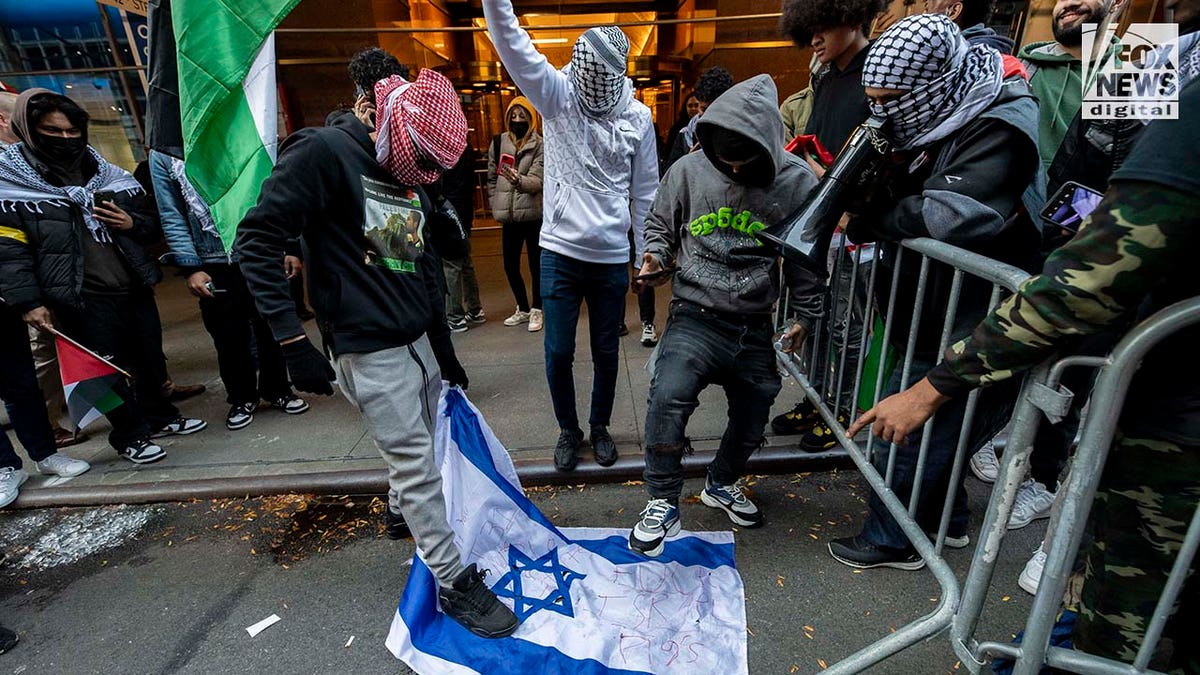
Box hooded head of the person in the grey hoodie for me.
[696,74,784,187]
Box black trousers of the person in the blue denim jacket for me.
[200,264,292,405]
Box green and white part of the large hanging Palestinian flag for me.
[170,0,299,249]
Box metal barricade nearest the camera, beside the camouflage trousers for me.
[950,298,1200,675]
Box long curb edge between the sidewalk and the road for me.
[10,448,853,508]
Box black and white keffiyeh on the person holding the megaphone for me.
[863,14,1004,150]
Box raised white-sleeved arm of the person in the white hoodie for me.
[484,0,568,118]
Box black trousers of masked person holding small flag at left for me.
[54,288,179,449]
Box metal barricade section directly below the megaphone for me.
[779,234,1028,673]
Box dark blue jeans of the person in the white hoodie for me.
[541,250,629,430]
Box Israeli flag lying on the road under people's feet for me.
[388,389,746,675]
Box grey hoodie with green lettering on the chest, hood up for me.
[646,74,823,328]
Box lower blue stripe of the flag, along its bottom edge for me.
[398,557,649,675]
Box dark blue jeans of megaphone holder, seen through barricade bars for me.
[863,353,1020,549]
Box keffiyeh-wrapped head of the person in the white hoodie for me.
[565,25,632,117]
